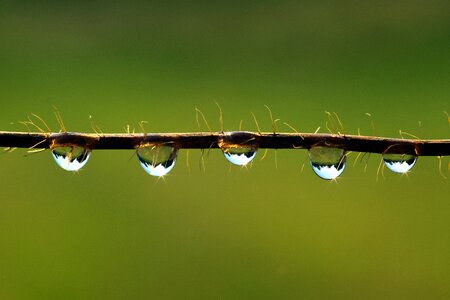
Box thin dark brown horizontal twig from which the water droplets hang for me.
[0,131,450,156]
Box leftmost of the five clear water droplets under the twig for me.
[52,146,91,171]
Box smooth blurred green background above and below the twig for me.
[0,0,450,299]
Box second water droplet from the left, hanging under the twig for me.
[137,145,178,176]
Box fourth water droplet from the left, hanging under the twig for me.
[309,146,347,180]
